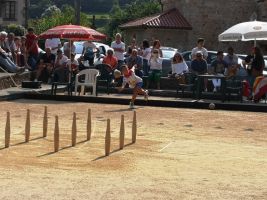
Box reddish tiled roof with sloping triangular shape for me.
[120,8,192,30]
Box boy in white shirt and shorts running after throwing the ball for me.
[118,65,148,109]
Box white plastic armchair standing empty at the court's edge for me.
[75,69,99,96]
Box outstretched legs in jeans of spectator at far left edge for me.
[0,47,24,73]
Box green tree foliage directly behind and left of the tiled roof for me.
[105,0,161,37]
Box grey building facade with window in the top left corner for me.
[0,0,27,26]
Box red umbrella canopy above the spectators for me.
[39,25,106,40]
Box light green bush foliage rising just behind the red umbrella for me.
[29,6,90,34]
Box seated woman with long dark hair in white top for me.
[172,52,188,77]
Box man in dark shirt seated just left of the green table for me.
[191,51,208,91]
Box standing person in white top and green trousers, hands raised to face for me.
[147,49,163,90]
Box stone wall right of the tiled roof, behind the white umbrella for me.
[158,0,267,53]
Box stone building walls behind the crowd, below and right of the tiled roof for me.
[121,0,267,53]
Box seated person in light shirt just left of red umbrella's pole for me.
[53,49,69,82]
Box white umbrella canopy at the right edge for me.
[219,21,267,42]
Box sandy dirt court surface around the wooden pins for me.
[0,100,267,200]
